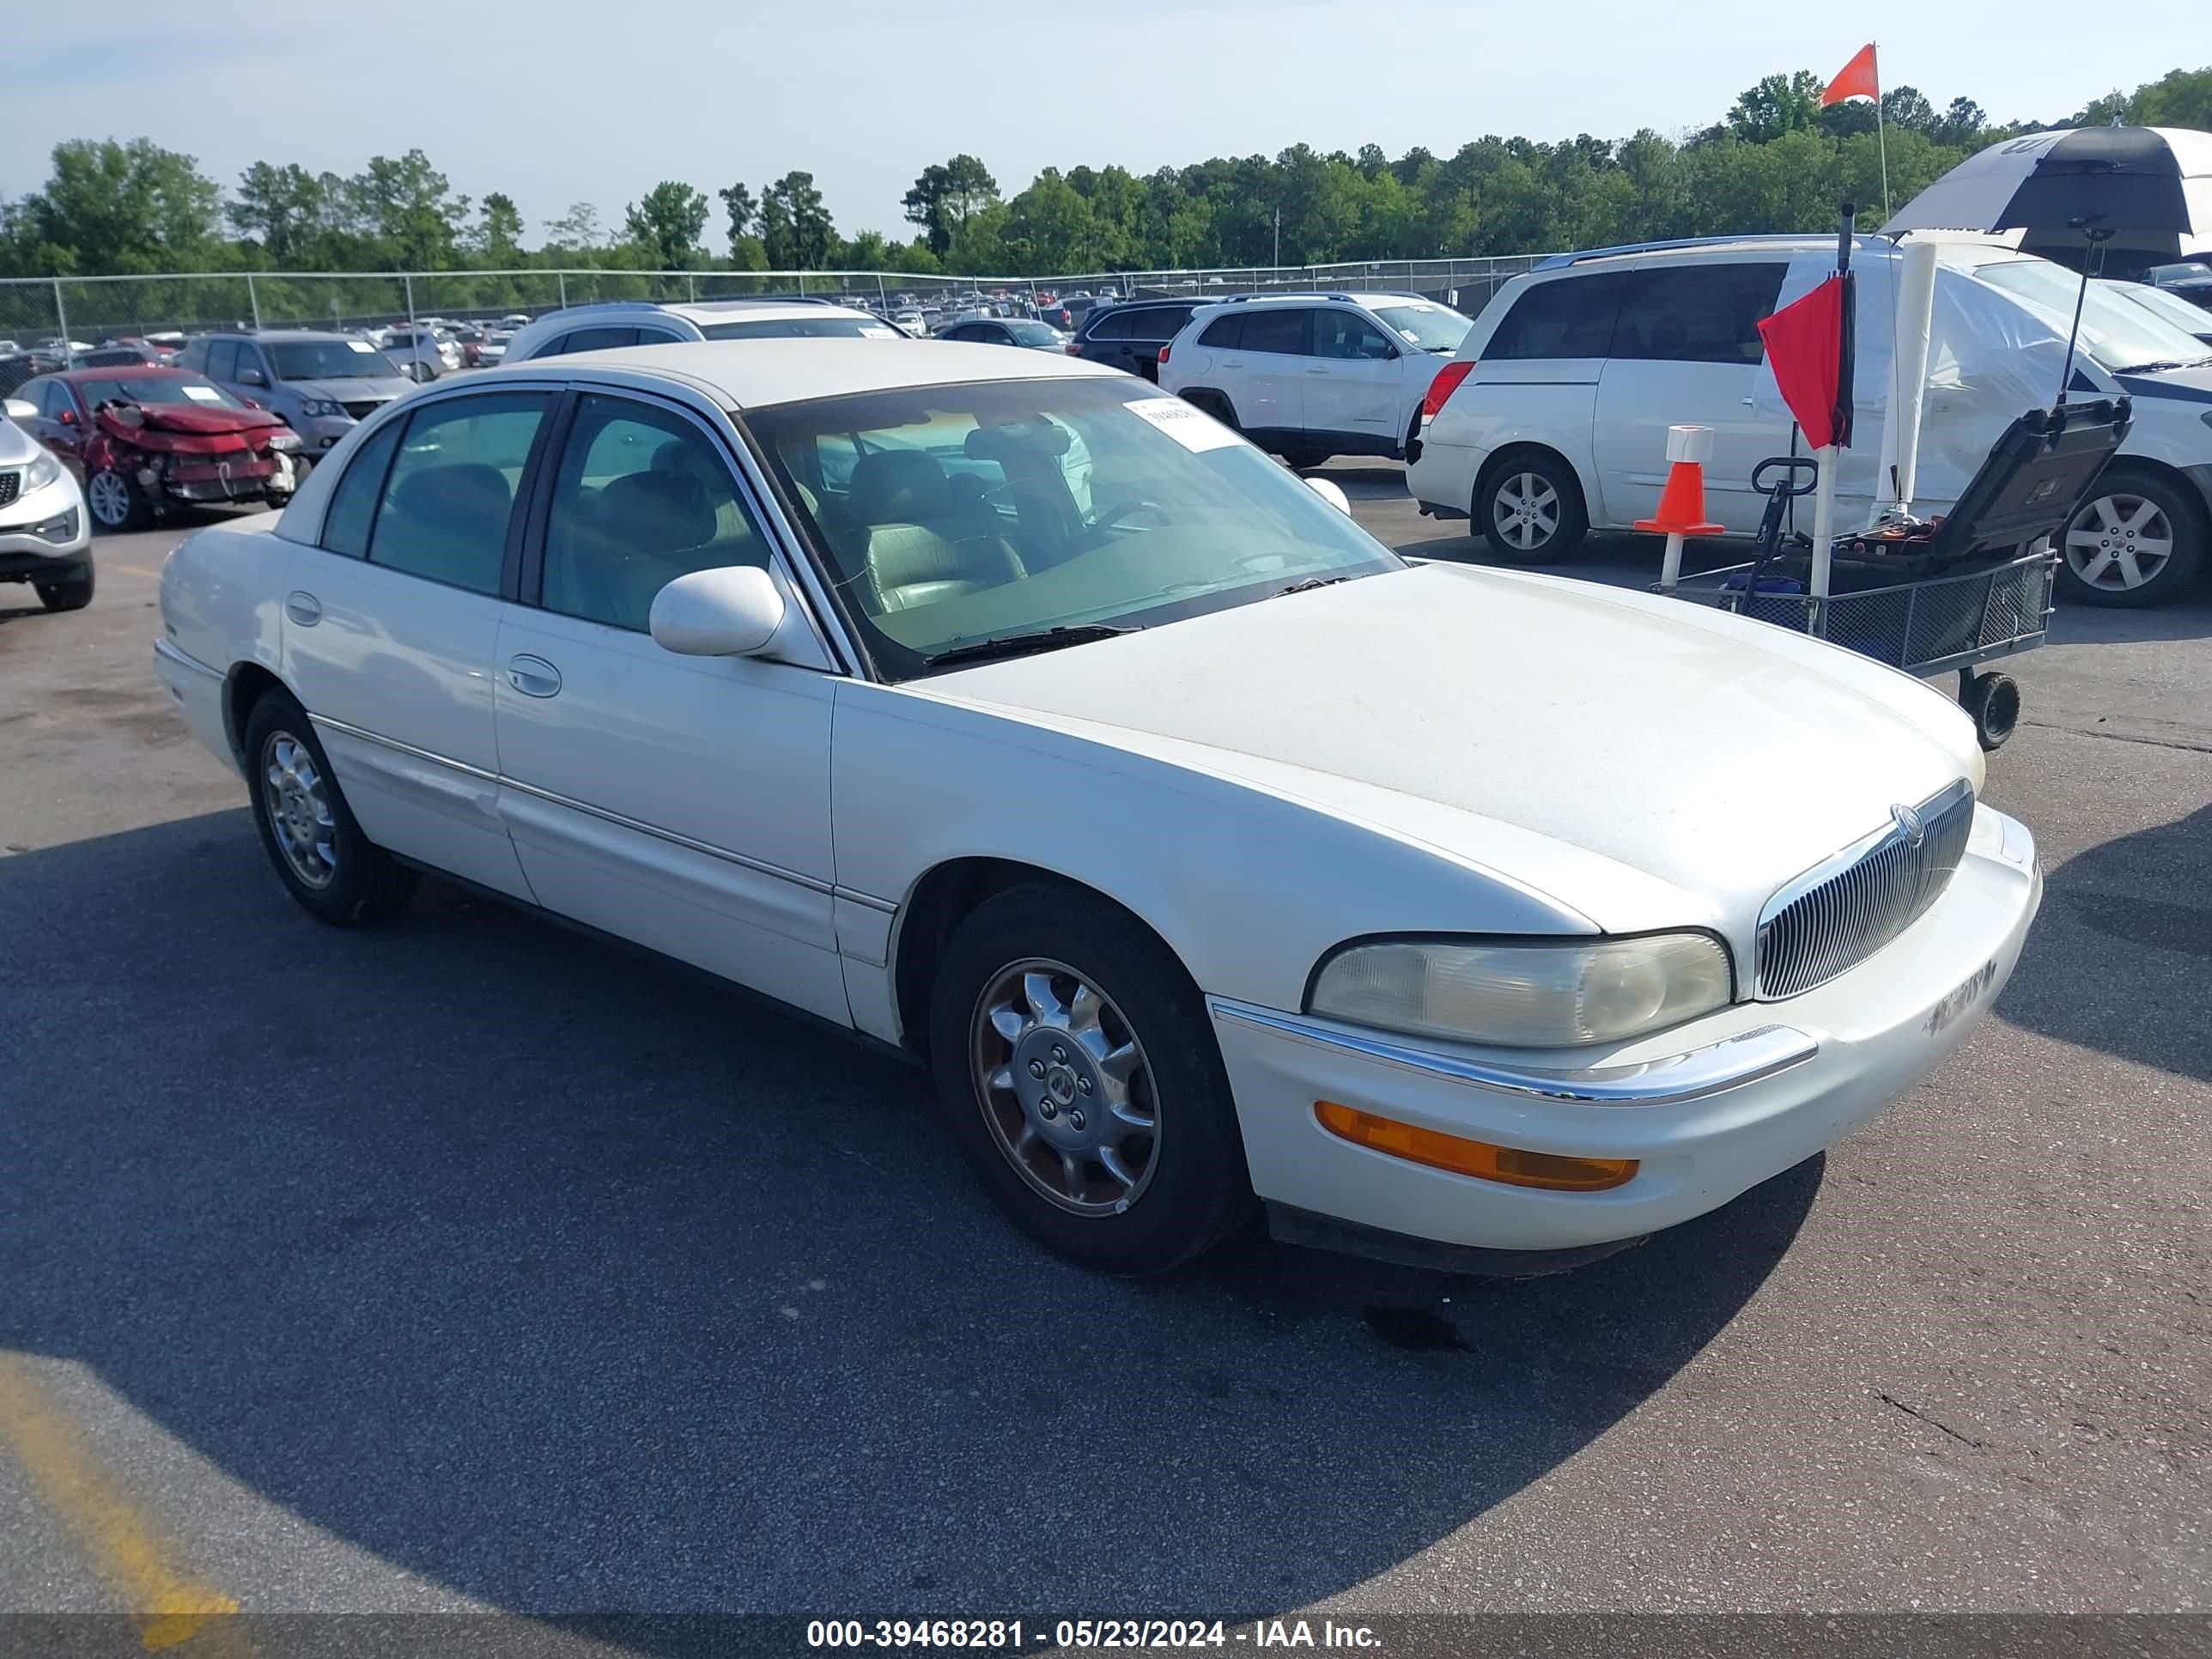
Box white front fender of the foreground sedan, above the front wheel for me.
[832,681,1697,1042]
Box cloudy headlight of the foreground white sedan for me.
[1305,933,1735,1048]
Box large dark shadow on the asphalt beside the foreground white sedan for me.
[0,810,1823,1613]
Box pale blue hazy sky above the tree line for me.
[0,0,2212,239]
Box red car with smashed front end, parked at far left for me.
[15,365,299,531]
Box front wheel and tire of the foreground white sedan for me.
[929,883,1255,1274]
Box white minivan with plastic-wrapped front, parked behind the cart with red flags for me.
[1407,237,2212,606]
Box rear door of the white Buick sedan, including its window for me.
[276,392,550,898]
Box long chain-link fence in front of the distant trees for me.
[0,254,1541,361]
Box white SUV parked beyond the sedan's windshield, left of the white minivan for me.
[1159,295,1471,467]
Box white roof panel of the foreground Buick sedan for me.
[469,338,1128,410]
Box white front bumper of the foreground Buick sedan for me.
[1207,807,2042,1255]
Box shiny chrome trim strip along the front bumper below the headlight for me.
[1206,998,1820,1106]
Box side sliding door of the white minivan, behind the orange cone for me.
[1590,257,1790,533]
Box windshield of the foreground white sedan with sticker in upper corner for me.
[741,376,1402,679]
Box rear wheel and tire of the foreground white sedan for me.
[246,690,418,927]
